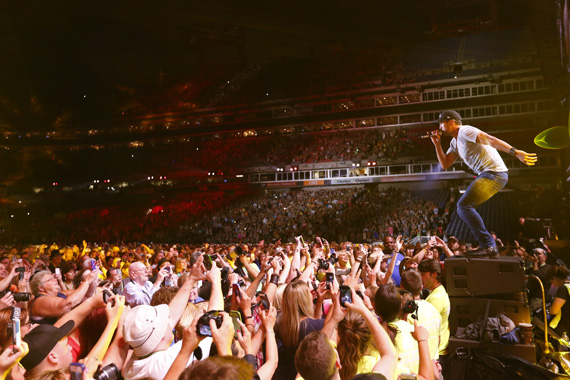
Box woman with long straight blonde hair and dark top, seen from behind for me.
[273,281,325,380]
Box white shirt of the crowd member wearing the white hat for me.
[122,337,213,380]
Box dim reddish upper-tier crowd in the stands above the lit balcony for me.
[5,127,422,189]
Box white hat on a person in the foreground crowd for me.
[123,305,170,357]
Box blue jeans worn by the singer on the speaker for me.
[457,172,509,248]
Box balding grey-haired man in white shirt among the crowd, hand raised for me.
[123,261,168,307]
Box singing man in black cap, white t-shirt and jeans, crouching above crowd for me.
[430,111,537,258]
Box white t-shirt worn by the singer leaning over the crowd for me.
[447,125,508,175]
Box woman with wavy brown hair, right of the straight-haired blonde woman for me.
[337,311,380,380]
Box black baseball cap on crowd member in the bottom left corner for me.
[20,321,75,371]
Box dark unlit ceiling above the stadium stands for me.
[0,0,524,131]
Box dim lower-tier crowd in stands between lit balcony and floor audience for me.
[8,187,454,243]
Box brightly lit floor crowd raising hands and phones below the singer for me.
[0,226,560,380]
